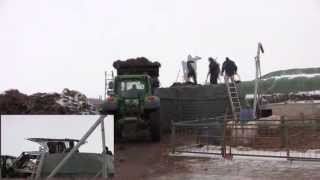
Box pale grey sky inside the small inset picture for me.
[1,115,113,156]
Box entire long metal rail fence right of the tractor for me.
[171,116,320,161]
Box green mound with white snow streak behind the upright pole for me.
[241,68,320,94]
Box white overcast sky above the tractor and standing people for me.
[0,0,320,97]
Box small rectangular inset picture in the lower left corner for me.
[1,115,114,179]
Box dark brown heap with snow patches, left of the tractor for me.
[0,89,98,114]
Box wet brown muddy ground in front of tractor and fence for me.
[114,136,320,180]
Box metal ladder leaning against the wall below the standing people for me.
[224,77,241,122]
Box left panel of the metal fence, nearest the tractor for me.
[171,117,229,155]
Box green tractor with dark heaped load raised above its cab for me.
[101,58,161,142]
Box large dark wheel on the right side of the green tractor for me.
[150,109,161,142]
